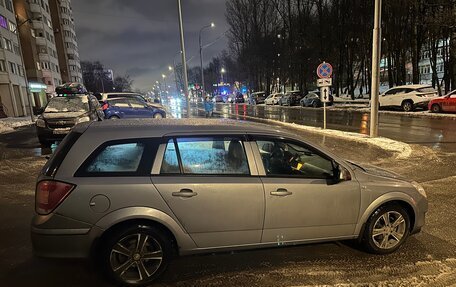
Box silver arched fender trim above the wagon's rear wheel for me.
[95,207,197,250]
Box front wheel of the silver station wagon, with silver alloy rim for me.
[362,204,410,254]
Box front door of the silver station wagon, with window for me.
[252,137,360,243]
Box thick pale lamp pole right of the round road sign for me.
[370,0,382,137]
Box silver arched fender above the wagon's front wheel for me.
[355,192,417,236]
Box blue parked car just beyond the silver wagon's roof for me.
[103,98,166,119]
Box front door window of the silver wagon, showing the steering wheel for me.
[257,140,334,179]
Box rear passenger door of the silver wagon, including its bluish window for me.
[152,135,264,248]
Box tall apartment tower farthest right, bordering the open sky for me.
[49,0,82,83]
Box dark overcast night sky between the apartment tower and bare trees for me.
[72,0,228,90]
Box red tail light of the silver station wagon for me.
[35,180,75,215]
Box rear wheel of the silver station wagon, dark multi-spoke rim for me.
[98,224,172,286]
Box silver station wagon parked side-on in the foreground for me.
[31,119,428,286]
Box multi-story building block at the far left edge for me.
[0,0,30,117]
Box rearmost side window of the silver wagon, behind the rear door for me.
[85,143,145,173]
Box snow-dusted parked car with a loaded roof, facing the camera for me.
[35,84,104,147]
